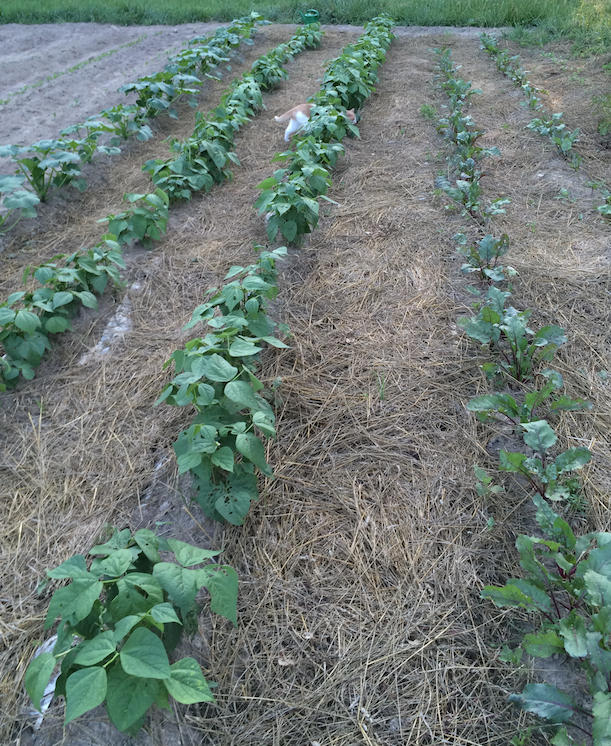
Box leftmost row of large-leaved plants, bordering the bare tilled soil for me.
[0,12,268,232]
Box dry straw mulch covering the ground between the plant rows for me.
[0,20,611,746]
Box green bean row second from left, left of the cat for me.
[0,26,322,387]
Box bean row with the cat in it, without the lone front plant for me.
[154,16,392,536]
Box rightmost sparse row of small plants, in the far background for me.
[480,33,583,171]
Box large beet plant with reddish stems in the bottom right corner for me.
[482,496,611,746]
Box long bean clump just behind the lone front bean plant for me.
[157,247,288,525]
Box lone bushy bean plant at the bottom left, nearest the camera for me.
[25,529,238,735]
